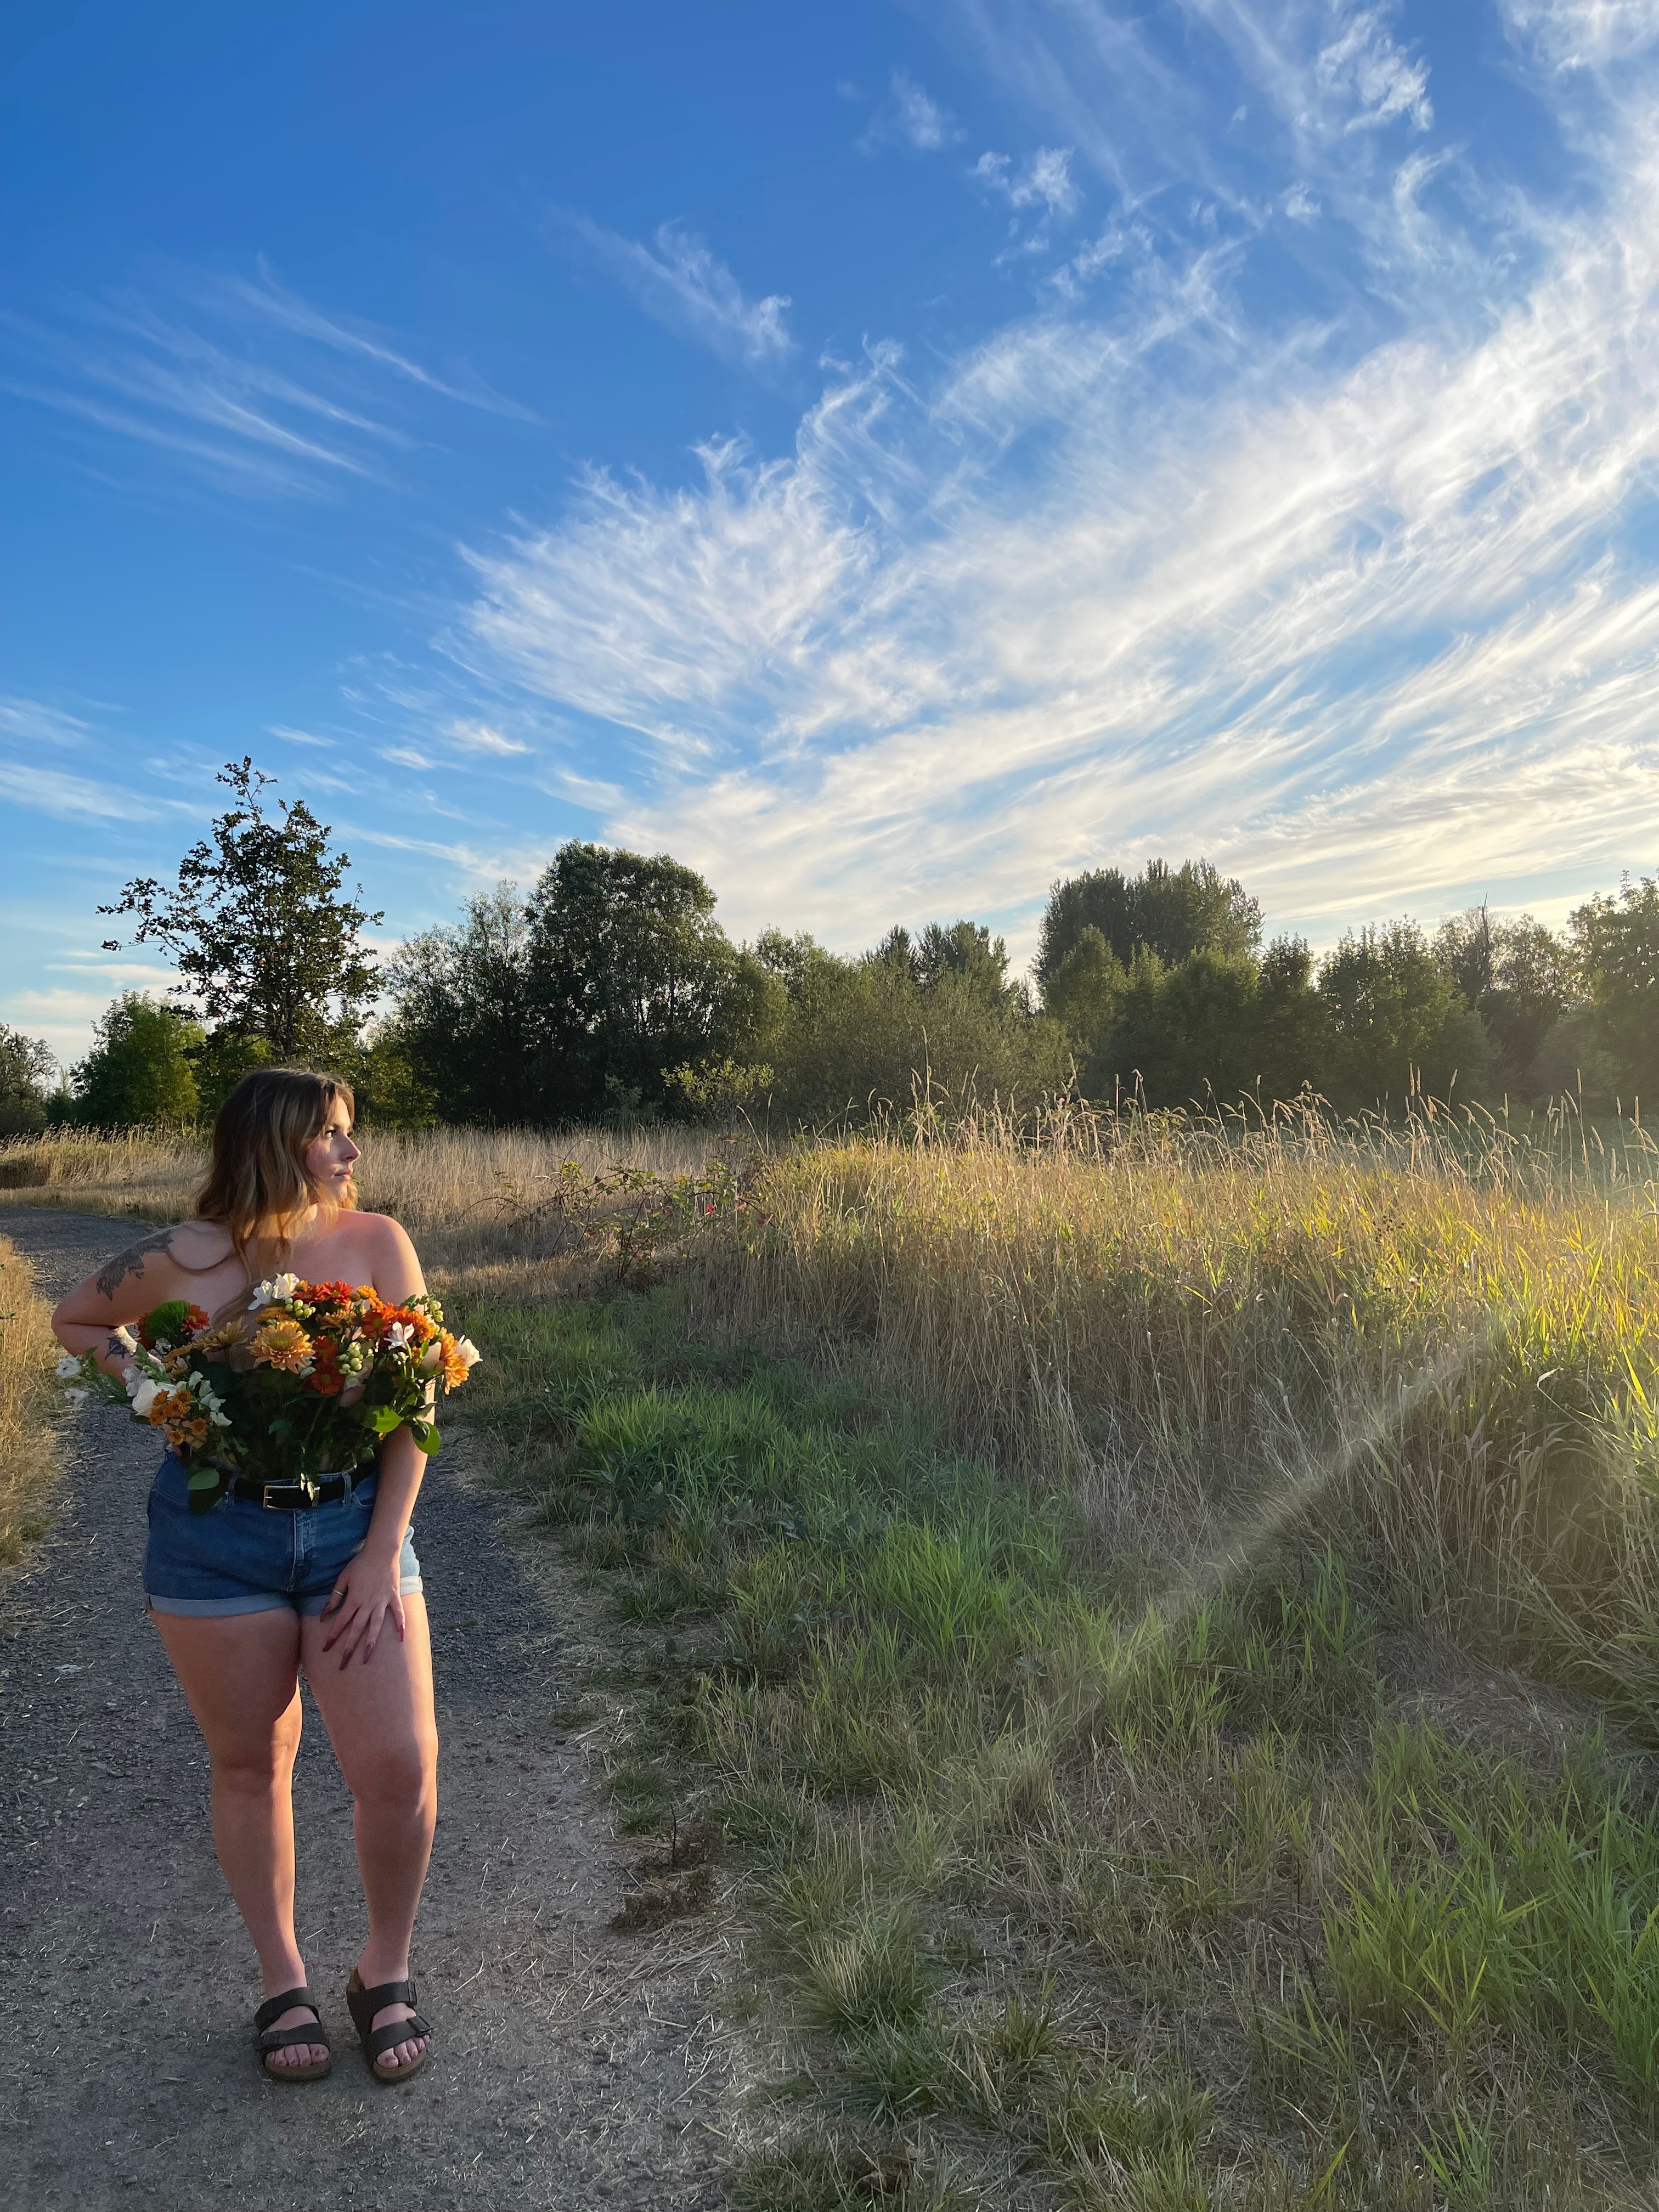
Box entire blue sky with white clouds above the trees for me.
[0,0,1659,1057]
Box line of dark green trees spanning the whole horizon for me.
[0,759,1659,1132]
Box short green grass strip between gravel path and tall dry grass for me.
[465,1294,1659,2212]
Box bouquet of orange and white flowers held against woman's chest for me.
[58,1274,478,1513]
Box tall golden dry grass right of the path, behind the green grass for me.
[710,1124,1659,1714]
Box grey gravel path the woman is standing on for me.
[0,1207,728,2212]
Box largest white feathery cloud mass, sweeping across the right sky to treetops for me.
[465,0,1659,943]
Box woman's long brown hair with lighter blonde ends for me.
[197,1068,356,1281]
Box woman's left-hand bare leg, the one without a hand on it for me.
[150,1606,328,2066]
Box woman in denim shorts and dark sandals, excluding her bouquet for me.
[53,1068,438,2081]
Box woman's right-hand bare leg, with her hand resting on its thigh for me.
[301,1595,438,2068]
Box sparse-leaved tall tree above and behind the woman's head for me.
[97,757,383,1075]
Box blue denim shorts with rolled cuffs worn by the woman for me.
[144,1453,420,1615]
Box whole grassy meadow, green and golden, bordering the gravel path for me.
[0,1115,1659,2212]
